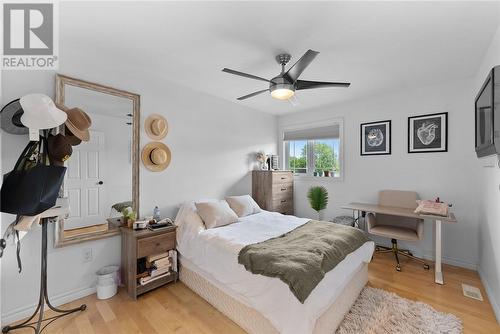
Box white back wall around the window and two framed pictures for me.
[279,81,478,268]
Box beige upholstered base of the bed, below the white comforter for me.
[180,262,368,334]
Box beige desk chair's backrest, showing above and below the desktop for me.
[376,190,422,235]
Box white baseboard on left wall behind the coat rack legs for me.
[1,287,96,326]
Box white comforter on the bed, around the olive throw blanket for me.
[178,211,374,334]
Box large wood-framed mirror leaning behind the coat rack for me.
[54,74,140,247]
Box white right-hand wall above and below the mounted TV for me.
[469,23,500,322]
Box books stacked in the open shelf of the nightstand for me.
[138,250,177,285]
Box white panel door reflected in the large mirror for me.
[64,131,106,230]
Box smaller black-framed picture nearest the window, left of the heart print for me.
[359,120,392,156]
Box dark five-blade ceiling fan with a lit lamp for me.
[222,49,350,101]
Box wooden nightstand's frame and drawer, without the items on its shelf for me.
[120,226,178,299]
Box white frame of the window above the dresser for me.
[279,118,345,182]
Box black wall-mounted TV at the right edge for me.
[475,65,500,157]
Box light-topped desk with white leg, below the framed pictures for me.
[342,203,457,284]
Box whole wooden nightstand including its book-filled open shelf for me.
[121,226,177,299]
